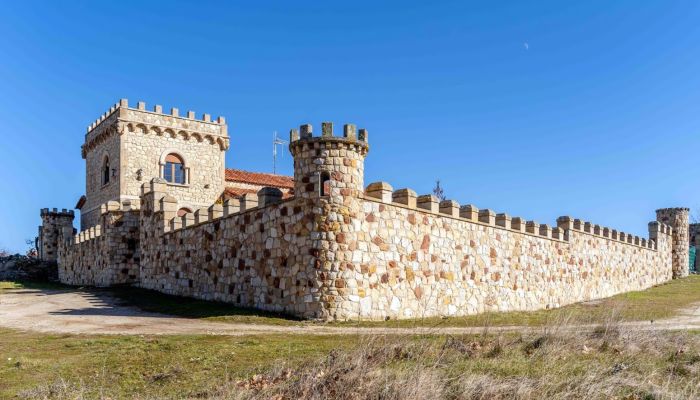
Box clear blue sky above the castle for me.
[0,1,700,251]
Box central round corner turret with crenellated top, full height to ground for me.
[289,122,369,319]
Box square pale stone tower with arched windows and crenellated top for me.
[80,99,229,230]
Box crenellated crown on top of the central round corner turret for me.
[289,122,369,154]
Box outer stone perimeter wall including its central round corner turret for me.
[46,118,688,320]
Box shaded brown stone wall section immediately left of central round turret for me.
[140,180,322,318]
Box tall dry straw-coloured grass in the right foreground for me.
[10,323,700,400]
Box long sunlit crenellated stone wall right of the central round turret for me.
[308,183,672,319]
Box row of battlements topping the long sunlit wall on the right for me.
[365,182,673,249]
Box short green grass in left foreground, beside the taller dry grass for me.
[0,330,354,399]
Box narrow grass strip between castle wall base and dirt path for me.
[0,275,700,328]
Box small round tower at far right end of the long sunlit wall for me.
[656,207,690,279]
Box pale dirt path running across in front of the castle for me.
[0,289,700,335]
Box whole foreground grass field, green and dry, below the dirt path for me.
[0,325,700,400]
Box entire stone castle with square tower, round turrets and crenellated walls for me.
[39,100,690,320]
